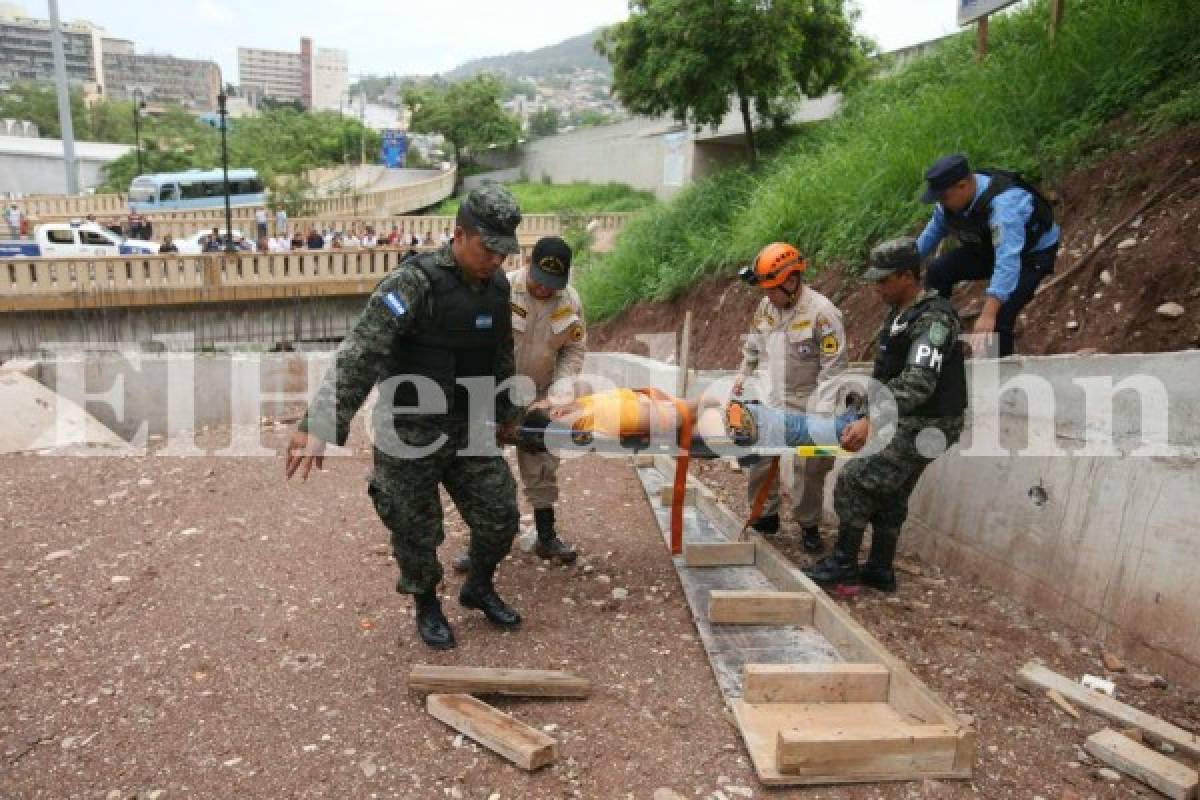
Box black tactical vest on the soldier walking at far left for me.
[388,254,512,417]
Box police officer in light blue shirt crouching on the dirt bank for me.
[917,155,1058,357]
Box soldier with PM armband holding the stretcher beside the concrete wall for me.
[805,236,967,591]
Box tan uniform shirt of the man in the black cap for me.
[509,269,588,399]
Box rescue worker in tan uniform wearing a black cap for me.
[454,236,587,570]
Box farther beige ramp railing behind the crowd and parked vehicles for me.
[16,169,457,222]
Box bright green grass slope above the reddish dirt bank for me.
[578,0,1200,320]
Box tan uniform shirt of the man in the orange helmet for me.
[738,287,850,413]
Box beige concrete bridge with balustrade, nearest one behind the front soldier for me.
[0,213,631,357]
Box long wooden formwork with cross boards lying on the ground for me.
[635,456,976,786]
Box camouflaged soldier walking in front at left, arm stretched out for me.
[286,185,521,649]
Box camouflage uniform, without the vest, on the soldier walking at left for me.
[300,190,520,595]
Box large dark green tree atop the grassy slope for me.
[595,0,870,162]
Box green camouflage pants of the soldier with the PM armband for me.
[833,416,962,544]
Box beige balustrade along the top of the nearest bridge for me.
[0,246,532,313]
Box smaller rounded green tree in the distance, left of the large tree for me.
[404,74,521,161]
